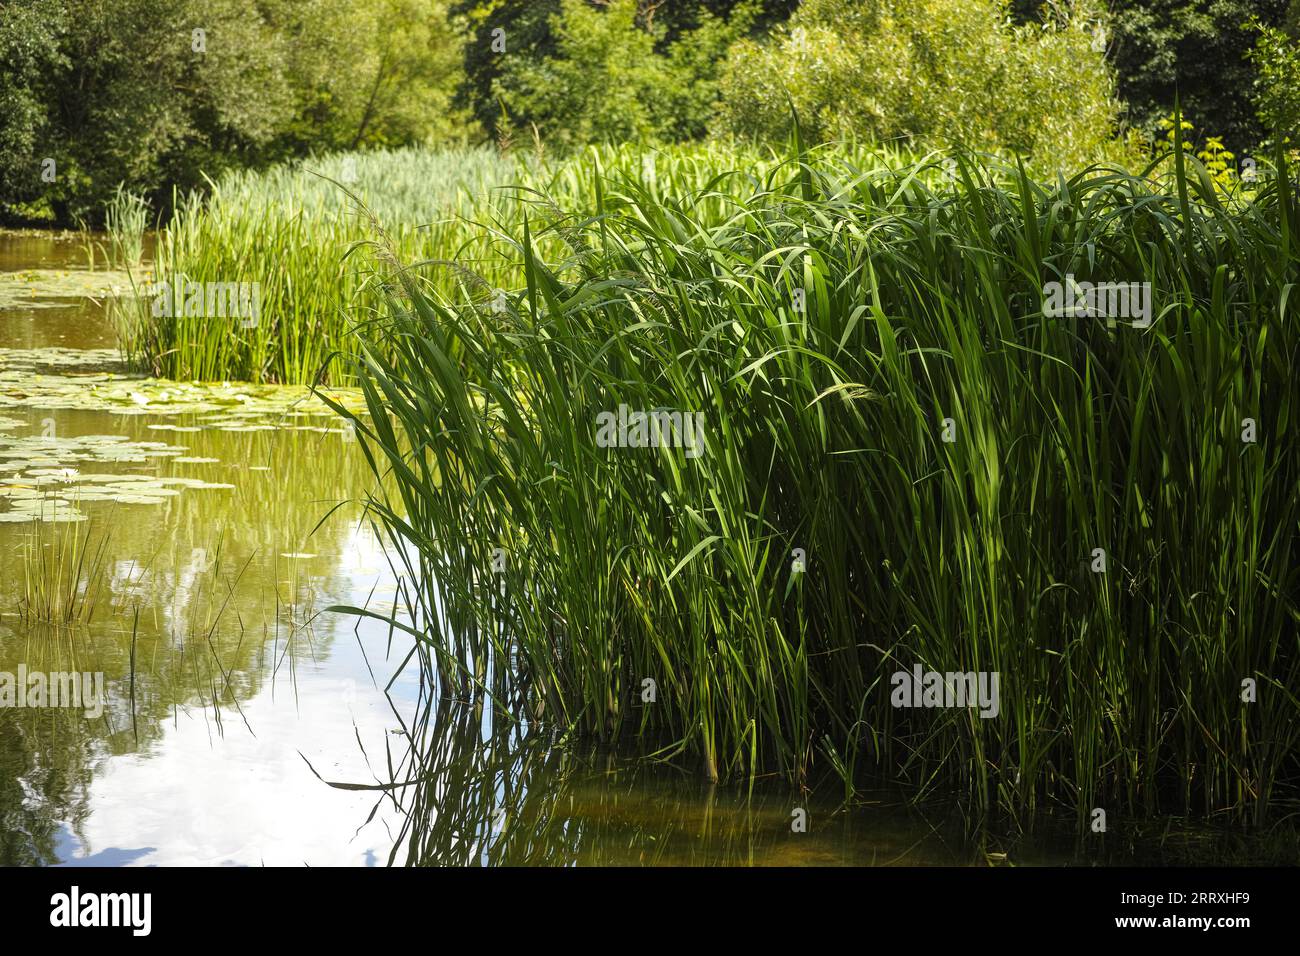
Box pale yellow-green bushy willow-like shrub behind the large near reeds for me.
[720,0,1118,168]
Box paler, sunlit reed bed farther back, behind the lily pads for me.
[113,146,785,384]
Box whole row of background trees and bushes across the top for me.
[0,0,1300,222]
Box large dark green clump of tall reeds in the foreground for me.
[332,136,1300,822]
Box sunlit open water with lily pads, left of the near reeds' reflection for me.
[0,234,407,865]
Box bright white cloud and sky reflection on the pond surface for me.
[60,541,417,866]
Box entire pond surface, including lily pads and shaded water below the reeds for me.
[0,233,1279,866]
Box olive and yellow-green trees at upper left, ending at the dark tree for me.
[0,0,467,221]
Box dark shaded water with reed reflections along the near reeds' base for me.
[345,687,1300,866]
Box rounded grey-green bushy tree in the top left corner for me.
[0,0,295,221]
